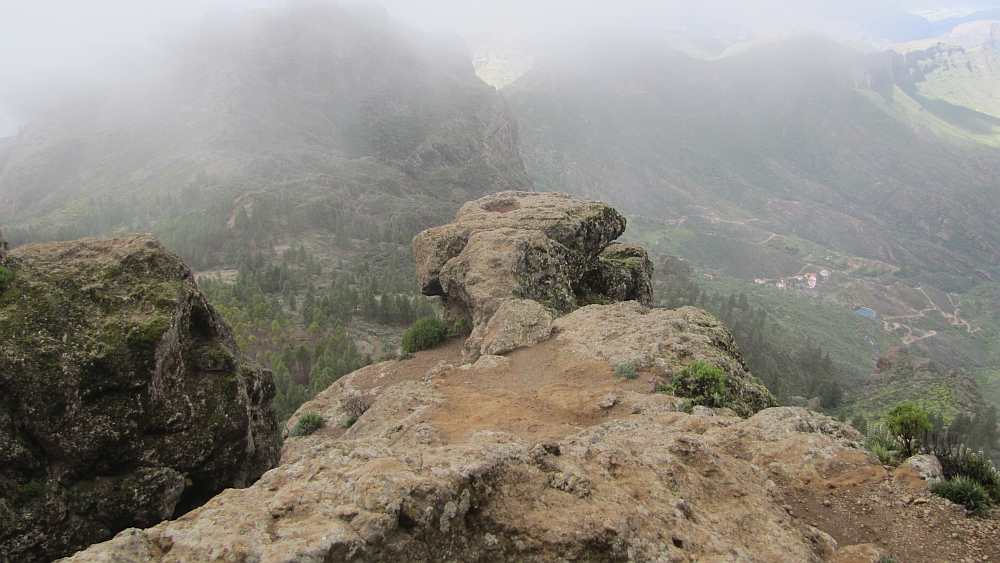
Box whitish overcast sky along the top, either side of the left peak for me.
[0,0,1000,135]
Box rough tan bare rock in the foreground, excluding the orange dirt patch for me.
[58,366,874,563]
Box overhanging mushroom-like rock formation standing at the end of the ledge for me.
[413,191,653,351]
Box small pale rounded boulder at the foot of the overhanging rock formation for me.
[483,299,552,355]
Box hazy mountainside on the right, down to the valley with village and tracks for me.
[504,36,1000,412]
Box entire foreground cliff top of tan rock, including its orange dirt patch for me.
[56,342,998,563]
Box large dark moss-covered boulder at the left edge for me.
[0,235,278,561]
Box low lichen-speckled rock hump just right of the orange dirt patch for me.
[554,301,778,417]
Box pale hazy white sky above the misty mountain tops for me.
[0,0,1000,137]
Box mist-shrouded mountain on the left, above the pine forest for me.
[0,4,530,234]
